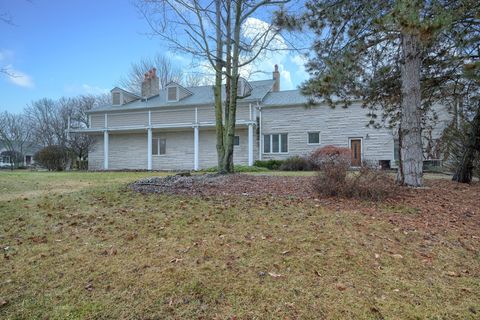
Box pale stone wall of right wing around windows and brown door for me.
[262,104,393,165]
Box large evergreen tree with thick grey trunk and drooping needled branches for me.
[277,0,480,187]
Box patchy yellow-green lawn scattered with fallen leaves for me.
[0,172,480,319]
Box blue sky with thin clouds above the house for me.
[0,0,307,112]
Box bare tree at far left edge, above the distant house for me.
[0,111,32,168]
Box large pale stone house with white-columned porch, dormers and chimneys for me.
[72,66,450,170]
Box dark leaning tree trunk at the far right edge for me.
[453,106,480,183]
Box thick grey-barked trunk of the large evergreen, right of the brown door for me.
[400,32,423,187]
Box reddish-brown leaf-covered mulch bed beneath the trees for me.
[129,174,480,236]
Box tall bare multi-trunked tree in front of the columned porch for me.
[136,0,290,173]
